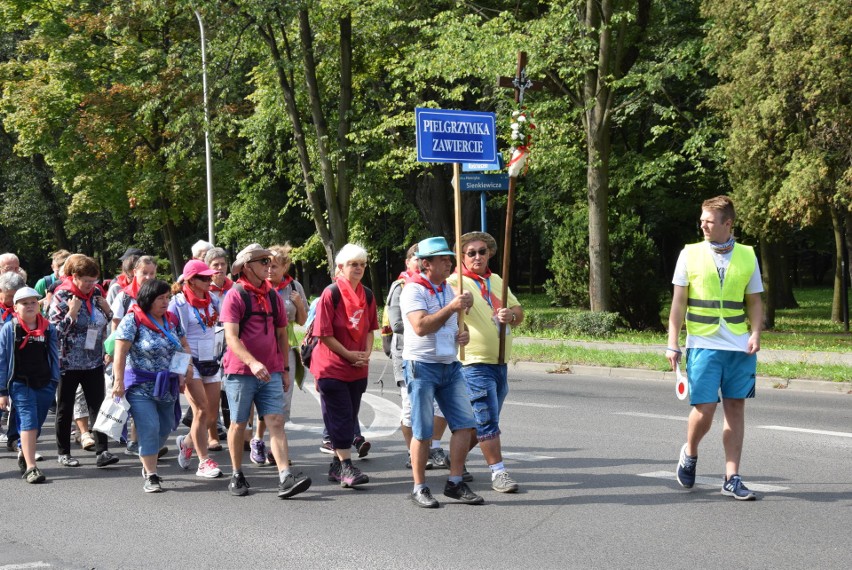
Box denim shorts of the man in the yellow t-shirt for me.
[462,364,509,441]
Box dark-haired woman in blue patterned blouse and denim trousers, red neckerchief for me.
[112,279,192,493]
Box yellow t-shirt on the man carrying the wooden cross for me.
[447,272,520,364]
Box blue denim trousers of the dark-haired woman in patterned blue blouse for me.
[125,382,175,456]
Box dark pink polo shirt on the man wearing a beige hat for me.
[221,288,287,375]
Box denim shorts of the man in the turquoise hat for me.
[405,360,476,441]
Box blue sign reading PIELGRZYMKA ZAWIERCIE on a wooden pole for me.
[414,107,497,162]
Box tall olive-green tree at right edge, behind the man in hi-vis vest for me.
[703,0,852,324]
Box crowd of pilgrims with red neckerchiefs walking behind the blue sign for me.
[0,232,524,508]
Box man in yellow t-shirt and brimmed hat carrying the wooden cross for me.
[447,232,524,493]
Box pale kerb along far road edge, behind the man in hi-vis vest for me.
[510,361,852,395]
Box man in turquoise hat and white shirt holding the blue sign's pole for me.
[400,237,483,508]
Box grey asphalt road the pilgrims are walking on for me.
[0,360,852,570]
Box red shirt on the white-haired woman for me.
[311,289,379,382]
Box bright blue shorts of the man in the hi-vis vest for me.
[686,348,757,406]
